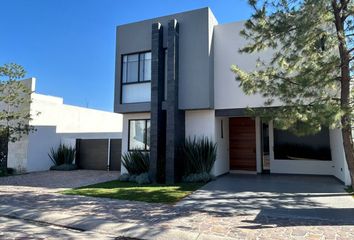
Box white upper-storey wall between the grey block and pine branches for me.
[214,22,280,109]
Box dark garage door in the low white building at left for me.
[76,139,122,171]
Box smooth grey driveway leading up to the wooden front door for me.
[178,174,354,224]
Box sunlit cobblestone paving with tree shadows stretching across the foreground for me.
[0,171,354,240]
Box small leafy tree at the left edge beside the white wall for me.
[0,63,33,173]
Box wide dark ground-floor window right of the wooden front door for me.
[274,128,332,161]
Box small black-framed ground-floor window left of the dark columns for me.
[128,119,150,151]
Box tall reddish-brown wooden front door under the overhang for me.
[229,117,256,171]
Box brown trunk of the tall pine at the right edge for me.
[332,0,354,188]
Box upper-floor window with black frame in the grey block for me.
[121,52,151,103]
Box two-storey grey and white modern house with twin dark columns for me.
[115,8,350,184]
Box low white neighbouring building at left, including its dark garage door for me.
[7,78,122,172]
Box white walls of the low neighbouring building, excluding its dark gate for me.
[8,78,123,172]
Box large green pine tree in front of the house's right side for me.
[232,0,354,186]
